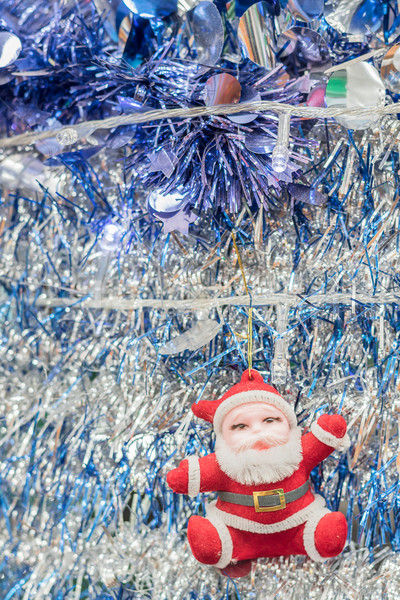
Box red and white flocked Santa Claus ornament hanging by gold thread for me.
[167,369,349,577]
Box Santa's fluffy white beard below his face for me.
[215,427,302,485]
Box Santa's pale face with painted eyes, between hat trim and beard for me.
[222,402,290,453]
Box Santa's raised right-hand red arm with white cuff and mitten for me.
[301,415,350,471]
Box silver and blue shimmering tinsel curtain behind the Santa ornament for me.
[0,115,400,600]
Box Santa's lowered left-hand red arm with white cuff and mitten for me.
[167,454,220,497]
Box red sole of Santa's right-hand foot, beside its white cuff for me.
[314,512,347,558]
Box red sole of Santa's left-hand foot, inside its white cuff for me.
[188,516,222,565]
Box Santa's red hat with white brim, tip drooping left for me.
[192,369,297,433]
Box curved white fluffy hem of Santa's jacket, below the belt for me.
[207,495,329,532]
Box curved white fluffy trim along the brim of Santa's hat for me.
[213,390,297,433]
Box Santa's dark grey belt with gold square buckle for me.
[218,481,309,512]
